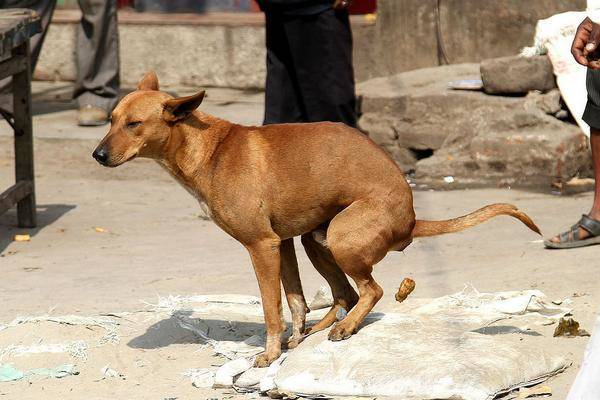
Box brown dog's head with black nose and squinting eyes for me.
[92,72,205,167]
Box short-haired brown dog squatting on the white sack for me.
[93,73,539,366]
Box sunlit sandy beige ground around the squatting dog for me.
[0,84,600,399]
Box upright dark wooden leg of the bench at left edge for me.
[12,41,37,228]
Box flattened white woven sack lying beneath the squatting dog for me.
[275,290,569,400]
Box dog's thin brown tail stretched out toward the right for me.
[412,203,542,238]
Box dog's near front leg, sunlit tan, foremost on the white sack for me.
[247,239,285,367]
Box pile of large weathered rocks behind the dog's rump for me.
[357,58,591,188]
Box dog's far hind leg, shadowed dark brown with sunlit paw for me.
[302,233,358,334]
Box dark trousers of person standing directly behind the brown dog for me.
[264,9,356,126]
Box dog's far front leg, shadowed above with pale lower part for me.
[280,239,308,349]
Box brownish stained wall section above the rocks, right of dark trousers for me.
[373,0,586,76]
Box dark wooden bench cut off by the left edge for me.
[0,9,41,228]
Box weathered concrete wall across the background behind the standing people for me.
[35,0,585,88]
